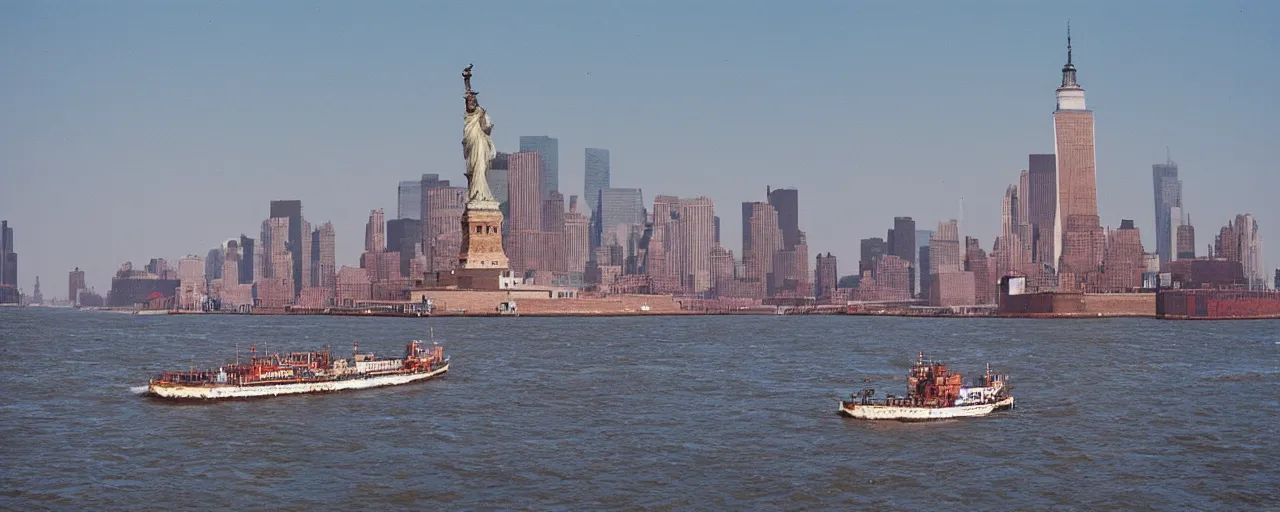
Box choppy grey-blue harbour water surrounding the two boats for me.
[0,308,1280,511]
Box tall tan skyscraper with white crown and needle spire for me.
[1053,23,1106,289]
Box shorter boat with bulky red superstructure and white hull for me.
[840,352,1014,421]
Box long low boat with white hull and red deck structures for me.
[145,339,449,399]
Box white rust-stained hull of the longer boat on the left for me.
[147,364,449,399]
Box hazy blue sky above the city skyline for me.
[0,0,1280,297]
